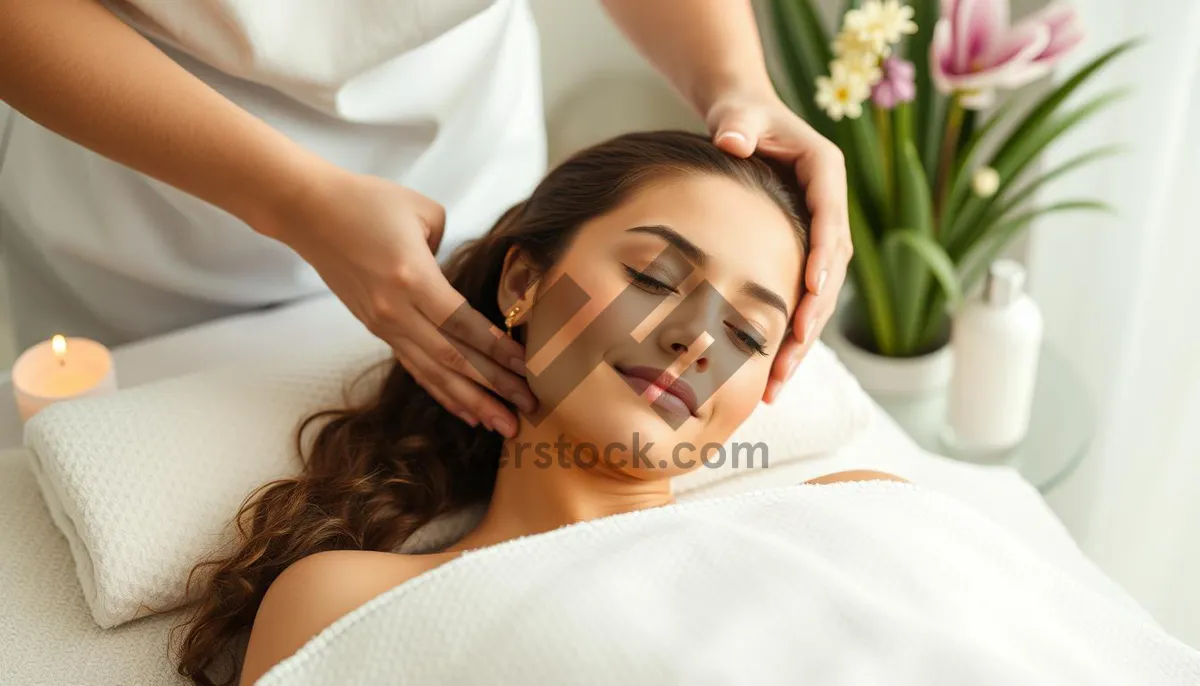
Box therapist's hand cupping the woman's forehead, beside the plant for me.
[707,94,853,403]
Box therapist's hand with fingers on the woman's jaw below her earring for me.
[272,172,535,437]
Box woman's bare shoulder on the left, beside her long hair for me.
[239,550,448,686]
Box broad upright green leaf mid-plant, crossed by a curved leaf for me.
[884,139,944,353]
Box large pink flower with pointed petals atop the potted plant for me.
[929,0,1084,109]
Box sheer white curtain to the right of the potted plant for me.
[1031,0,1200,645]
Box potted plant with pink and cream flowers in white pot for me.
[769,0,1133,395]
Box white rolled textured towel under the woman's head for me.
[25,319,872,627]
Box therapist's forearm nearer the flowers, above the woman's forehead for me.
[604,0,774,115]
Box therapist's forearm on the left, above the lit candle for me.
[0,0,329,238]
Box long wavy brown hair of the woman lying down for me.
[175,131,808,685]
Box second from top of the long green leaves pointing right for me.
[948,89,1126,258]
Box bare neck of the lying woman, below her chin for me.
[450,420,672,550]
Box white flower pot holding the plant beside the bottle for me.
[823,318,954,398]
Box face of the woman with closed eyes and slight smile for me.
[511,175,803,477]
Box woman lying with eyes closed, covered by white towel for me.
[169,132,1200,686]
